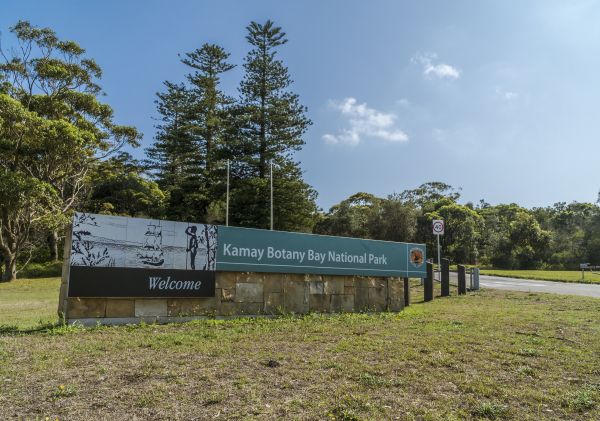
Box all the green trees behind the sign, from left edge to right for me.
[0,21,600,280]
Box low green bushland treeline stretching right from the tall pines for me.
[314,182,600,269]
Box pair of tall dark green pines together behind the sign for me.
[146,25,317,231]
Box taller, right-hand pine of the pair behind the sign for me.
[231,20,316,231]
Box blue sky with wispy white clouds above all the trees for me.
[0,0,600,210]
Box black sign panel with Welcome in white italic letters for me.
[69,266,215,298]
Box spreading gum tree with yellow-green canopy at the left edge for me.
[0,21,140,280]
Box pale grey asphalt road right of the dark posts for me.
[450,273,600,298]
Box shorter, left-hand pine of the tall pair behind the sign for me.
[148,44,234,221]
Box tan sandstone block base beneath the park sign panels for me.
[59,272,404,324]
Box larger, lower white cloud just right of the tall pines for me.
[323,97,408,145]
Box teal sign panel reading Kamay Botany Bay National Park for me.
[217,227,426,278]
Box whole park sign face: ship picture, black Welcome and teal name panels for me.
[66,213,426,298]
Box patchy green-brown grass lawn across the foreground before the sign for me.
[0,280,600,420]
